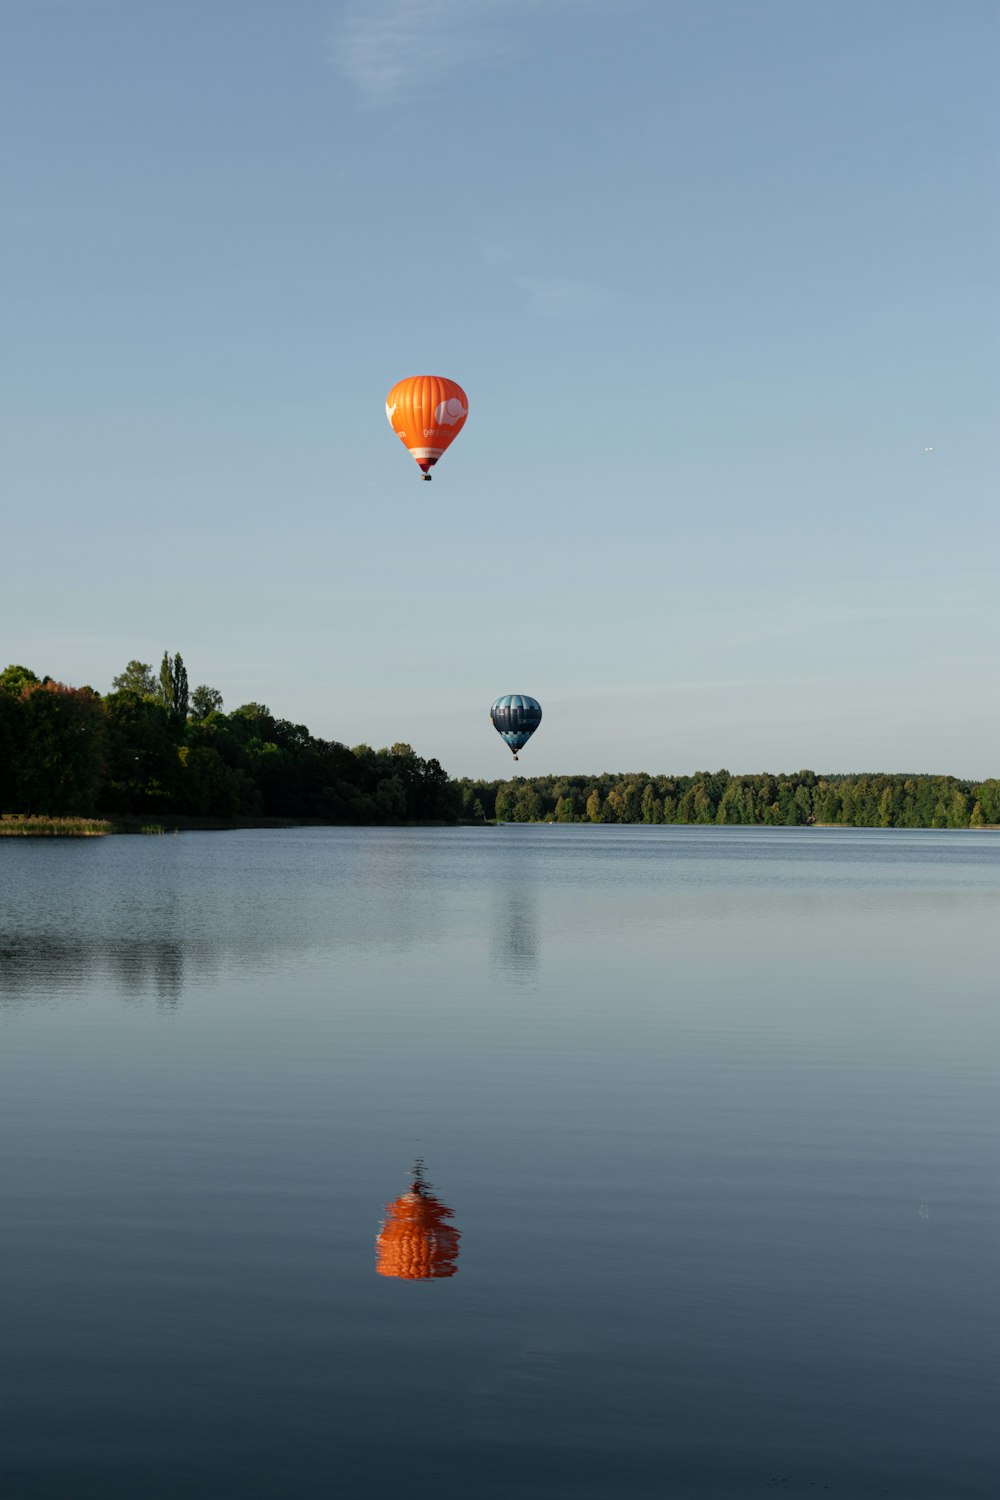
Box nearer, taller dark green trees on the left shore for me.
[0,651,462,824]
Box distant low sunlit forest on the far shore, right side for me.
[459,771,1000,828]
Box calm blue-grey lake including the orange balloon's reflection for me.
[0,825,1000,1500]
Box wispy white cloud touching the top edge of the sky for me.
[330,0,583,108]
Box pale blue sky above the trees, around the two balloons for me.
[0,0,1000,777]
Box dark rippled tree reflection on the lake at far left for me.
[0,933,197,1007]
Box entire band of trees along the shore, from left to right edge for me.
[0,651,1000,828]
